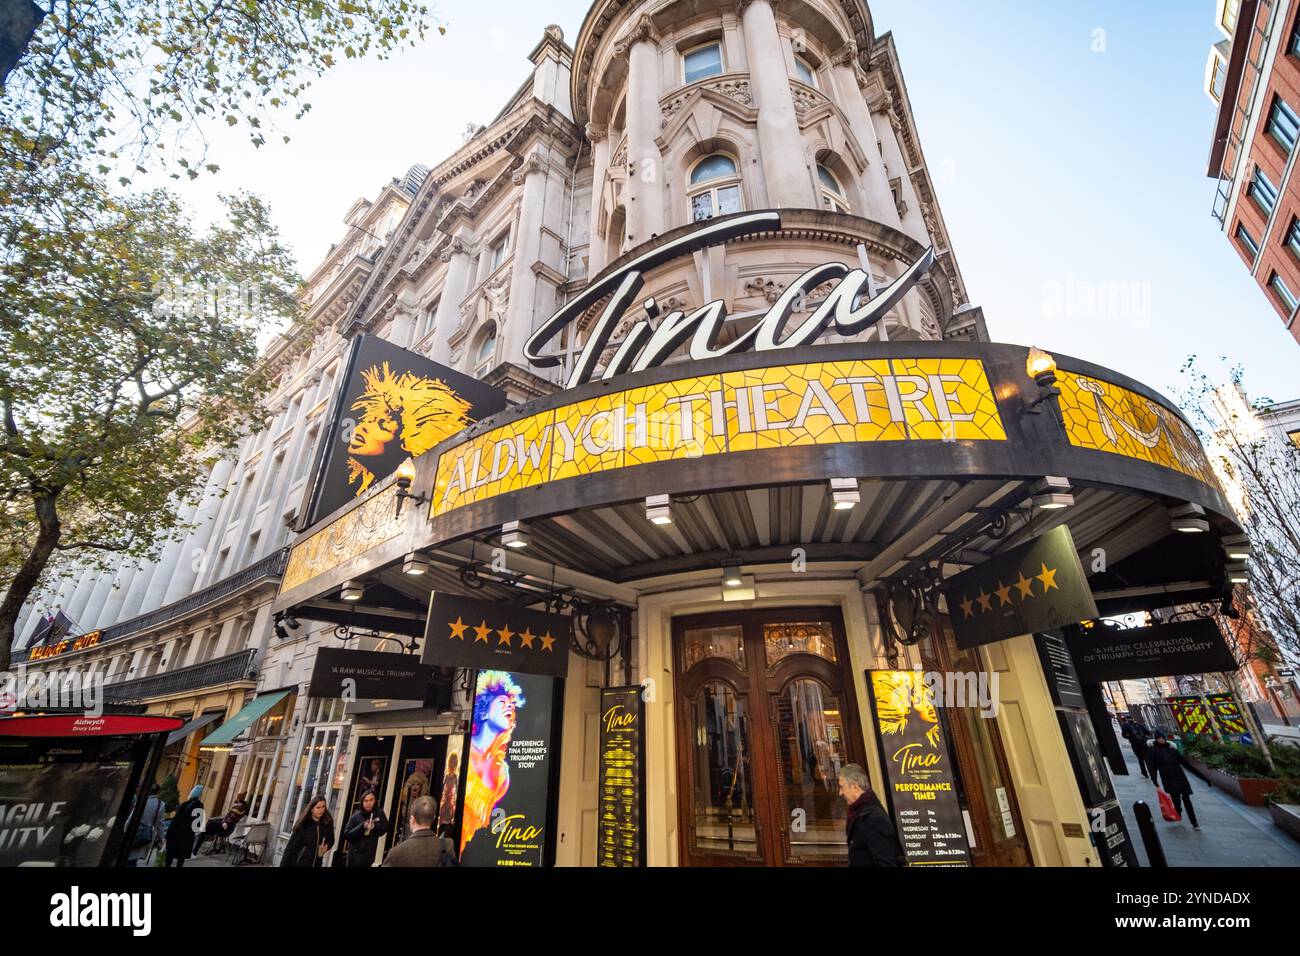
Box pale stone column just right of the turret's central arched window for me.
[741,0,818,209]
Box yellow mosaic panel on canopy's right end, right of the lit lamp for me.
[1057,369,1219,488]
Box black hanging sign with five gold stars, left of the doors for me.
[421,593,573,678]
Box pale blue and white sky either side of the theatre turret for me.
[157,0,1300,401]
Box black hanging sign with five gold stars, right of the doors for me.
[944,524,1097,648]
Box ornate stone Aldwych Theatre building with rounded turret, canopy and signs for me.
[10,0,1240,866]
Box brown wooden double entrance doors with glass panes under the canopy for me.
[673,607,865,866]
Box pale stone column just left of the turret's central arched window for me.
[616,16,665,246]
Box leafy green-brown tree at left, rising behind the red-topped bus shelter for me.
[0,184,302,670]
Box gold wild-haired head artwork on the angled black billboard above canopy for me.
[347,362,473,497]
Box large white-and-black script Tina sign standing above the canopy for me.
[524,211,935,389]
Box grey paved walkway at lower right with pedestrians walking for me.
[1110,740,1300,866]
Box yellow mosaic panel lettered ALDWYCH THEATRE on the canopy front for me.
[430,358,1006,516]
